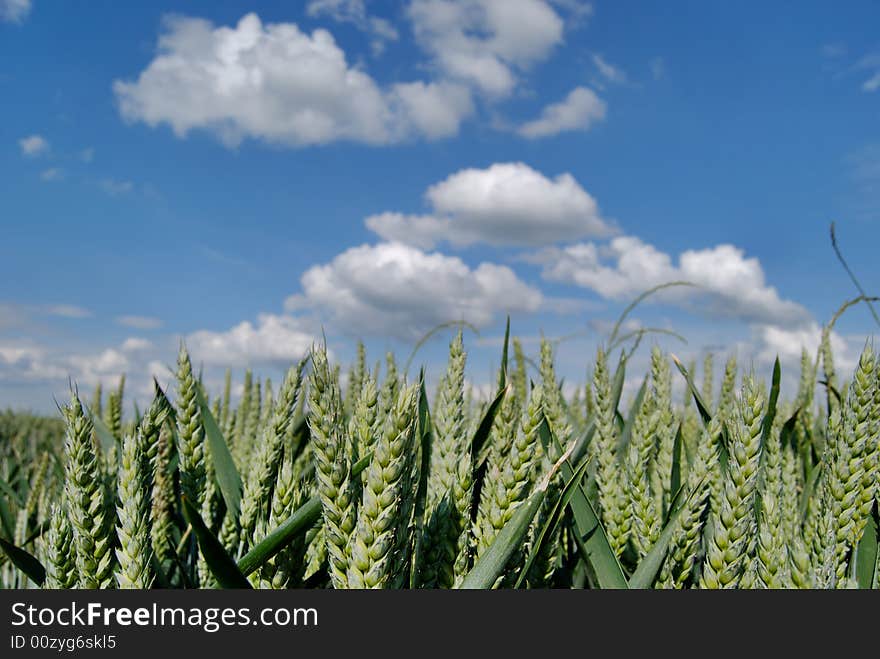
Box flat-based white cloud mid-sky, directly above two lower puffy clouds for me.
[365,162,613,248]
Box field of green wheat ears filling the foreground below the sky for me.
[0,300,880,589]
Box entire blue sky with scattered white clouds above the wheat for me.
[0,0,880,409]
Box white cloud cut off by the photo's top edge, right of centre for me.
[407,0,563,96]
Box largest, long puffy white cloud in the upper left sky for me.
[113,14,471,146]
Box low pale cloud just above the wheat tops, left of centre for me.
[186,314,316,366]
